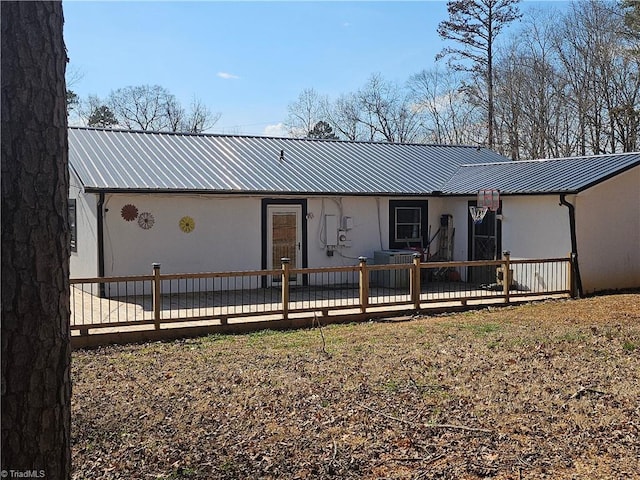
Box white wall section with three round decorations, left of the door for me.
[105,195,261,276]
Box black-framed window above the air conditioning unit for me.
[389,200,428,248]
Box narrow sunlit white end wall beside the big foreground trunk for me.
[69,172,98,278]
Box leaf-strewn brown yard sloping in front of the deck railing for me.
[72,293,640,480]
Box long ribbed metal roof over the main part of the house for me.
[69,127,506,195]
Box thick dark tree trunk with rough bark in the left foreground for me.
[0,1,71,480]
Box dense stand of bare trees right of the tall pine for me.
[488,0,640,159]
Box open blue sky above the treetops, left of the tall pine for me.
[63,0,564,135]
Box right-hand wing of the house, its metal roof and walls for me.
[442,153,640,293]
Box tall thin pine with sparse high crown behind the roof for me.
[436,0,520,148]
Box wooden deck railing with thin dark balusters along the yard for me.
[70,252,573,345]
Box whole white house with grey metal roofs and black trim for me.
[69,128,640,291]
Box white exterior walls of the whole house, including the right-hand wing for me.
[76,178,640,292]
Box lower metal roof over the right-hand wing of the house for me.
[442,153,640,195]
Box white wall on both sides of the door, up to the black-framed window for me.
[99,194,430,276]
